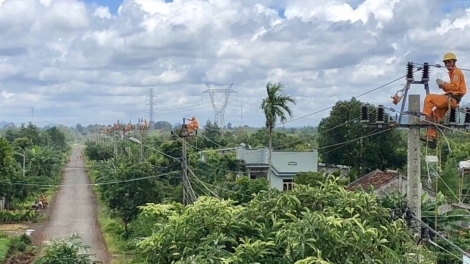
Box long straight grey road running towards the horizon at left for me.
[44,146,109,264]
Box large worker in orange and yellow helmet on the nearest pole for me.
[421,52,467,142]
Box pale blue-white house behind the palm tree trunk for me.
[236,144,318,191]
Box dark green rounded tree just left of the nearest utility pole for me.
[318,98,407,179]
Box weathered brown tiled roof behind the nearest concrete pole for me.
[348,170,436,200]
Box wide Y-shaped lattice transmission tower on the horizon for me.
[202,83,237,127]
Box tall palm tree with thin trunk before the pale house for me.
[260,82,297,188]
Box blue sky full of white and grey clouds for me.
[0,0,470,127]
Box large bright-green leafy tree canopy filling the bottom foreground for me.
[136,179,434,264]
